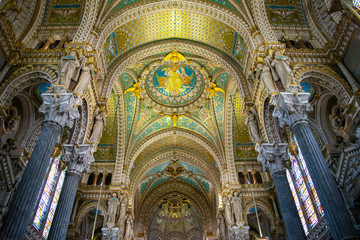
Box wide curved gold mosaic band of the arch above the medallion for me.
[104,10,246,66]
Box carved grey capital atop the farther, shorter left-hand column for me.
[62,144,95,176]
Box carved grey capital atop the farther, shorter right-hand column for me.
[258,143,289,176]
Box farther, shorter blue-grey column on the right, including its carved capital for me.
[258,143,306,240]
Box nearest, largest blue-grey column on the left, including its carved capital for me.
[0,88,79,239]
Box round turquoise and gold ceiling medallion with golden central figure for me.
[140,50,210,115]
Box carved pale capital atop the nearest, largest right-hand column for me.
[271,92,313,128]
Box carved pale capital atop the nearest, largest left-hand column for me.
[39,89,80,128]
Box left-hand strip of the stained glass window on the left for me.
[33,157,59,230]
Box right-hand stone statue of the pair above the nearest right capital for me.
[271,51,292,88]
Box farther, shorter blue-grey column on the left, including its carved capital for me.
[48,144,95,240]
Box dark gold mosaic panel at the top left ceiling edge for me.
[41,0,85,26]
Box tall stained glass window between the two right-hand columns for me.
[287,139,324,235]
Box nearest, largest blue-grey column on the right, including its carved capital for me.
[272,92,357,239]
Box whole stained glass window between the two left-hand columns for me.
[33,157,65,239]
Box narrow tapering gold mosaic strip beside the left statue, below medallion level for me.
[94,92,117,162]
